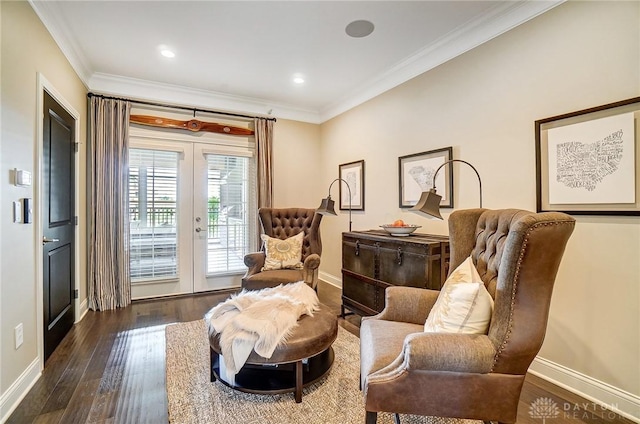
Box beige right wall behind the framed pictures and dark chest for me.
[321,2,640,410]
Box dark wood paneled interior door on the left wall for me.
[41,91,76,361]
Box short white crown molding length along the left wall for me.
[28,0,93,87]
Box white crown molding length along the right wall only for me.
[319,0,566,122]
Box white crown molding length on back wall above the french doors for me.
[88,72,321,124]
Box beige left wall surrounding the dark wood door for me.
[0,1,86,400]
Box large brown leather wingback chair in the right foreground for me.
[360,209,575,424]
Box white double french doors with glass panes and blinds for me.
[129,138,257,299]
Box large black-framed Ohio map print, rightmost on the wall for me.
[535,97,640,215]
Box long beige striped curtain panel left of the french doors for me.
[88,96,131,311]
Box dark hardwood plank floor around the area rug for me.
[7,282,631,424]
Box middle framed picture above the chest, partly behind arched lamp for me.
[398,147,453,208]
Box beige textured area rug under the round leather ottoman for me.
[166,320,478,424]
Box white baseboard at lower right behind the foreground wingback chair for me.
[529,357,640,423]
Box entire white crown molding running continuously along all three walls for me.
[28,0,565,124]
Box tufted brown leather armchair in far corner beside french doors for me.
[242,208,322,290]
